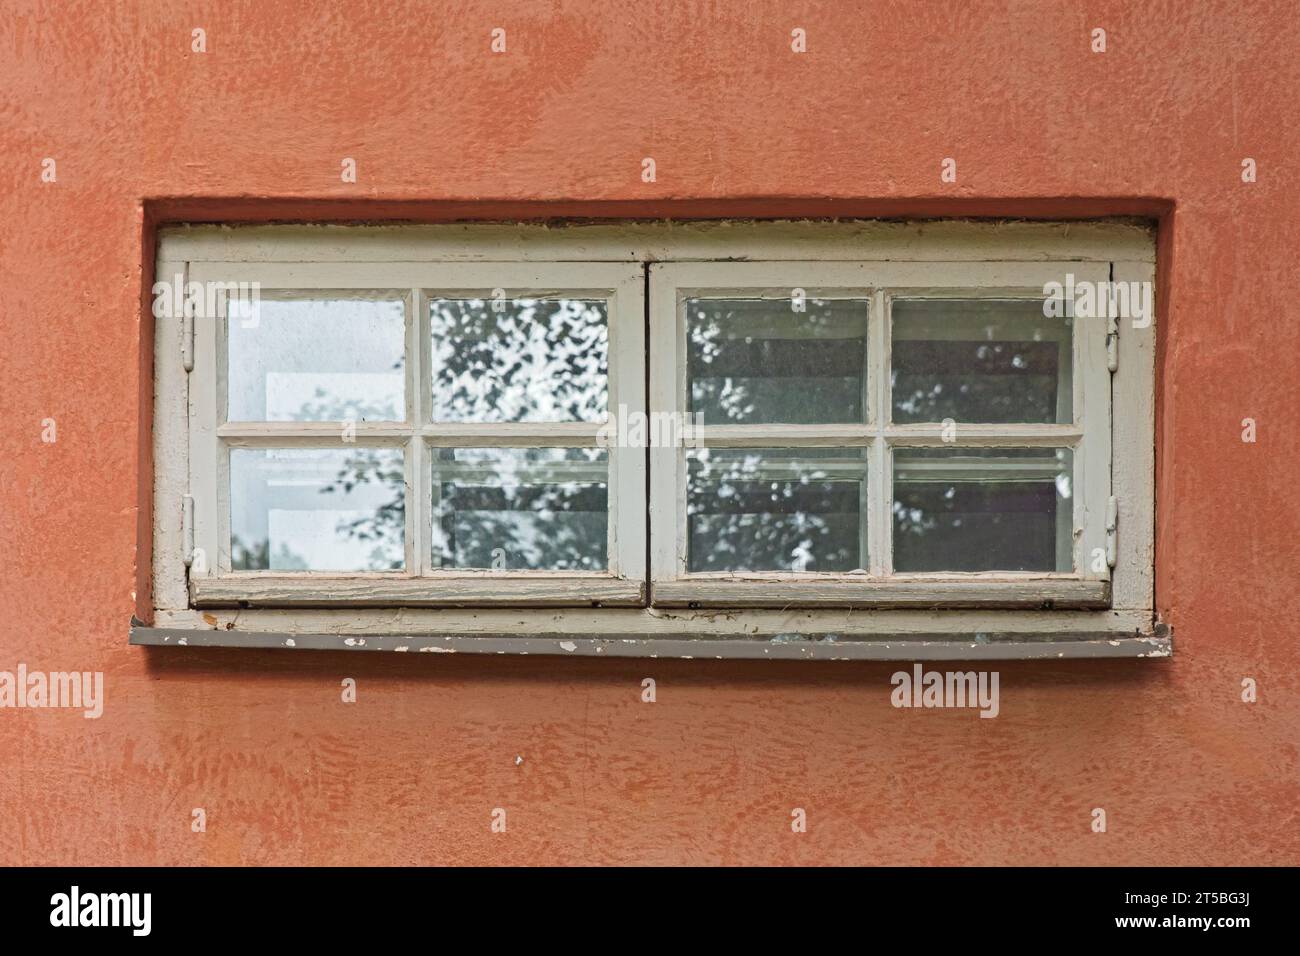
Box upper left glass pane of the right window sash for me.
[686,299,870,425]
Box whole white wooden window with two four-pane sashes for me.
[142,222,1160,656]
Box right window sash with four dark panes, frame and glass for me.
[650,261,1115,607]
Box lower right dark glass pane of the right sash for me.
[893,449,1074,571]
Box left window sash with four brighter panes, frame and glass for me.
[180,261,646,607]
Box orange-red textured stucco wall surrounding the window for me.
[0,0,1300,864]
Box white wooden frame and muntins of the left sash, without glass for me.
[189,263,646,607]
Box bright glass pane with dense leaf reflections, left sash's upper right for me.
[429,298,610,421]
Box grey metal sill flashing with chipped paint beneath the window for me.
[130,618,1174,661]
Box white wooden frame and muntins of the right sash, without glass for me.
[650,261,1110,607]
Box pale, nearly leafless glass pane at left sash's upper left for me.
[226,298,406,421]
